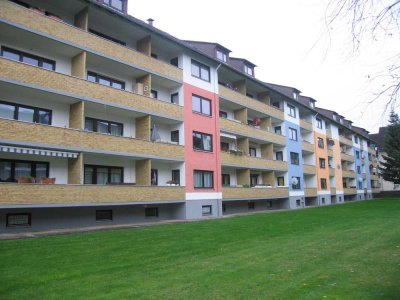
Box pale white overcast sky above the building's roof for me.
[128,0,400,133]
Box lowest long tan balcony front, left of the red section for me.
[0,183,185,206]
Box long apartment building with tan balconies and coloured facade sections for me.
[0,0,376,233]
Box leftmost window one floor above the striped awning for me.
[0,102,52,125]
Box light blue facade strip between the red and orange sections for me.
[285,121,304,192]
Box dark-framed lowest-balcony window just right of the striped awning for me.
[84,165,124,184]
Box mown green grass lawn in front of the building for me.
[0,199,400,299]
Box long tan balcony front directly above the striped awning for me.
[0,119,183,160]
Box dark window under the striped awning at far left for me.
[0,159,49,182]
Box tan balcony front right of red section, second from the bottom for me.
[221,152,288,171]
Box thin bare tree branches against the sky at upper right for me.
[326,0,400,112]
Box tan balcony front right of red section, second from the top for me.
[219,118,286,145]
